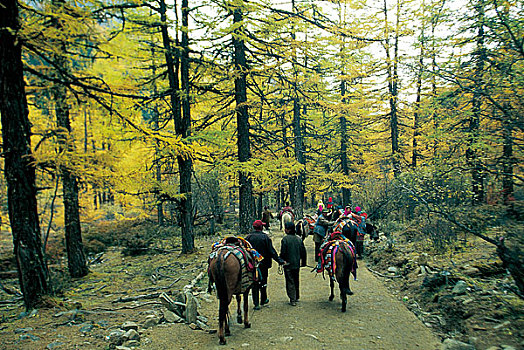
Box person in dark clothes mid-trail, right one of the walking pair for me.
[280,222,307,306]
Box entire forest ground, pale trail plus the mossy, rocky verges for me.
[0,220,524,350]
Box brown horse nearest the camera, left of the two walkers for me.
[208,248,252,345]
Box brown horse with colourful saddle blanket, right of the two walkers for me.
[322,238,356,312]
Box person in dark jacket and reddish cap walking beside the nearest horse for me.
[246,220,285,310]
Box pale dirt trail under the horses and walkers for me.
[144,229,440,350]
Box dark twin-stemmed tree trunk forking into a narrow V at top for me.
[160,0,195,254]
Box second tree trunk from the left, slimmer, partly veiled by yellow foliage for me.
[53,0,89,277]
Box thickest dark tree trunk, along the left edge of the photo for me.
[0,0,48,309]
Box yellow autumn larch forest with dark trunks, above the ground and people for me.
[0,0,524,334]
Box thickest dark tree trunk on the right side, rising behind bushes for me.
[466,0,487,205]
